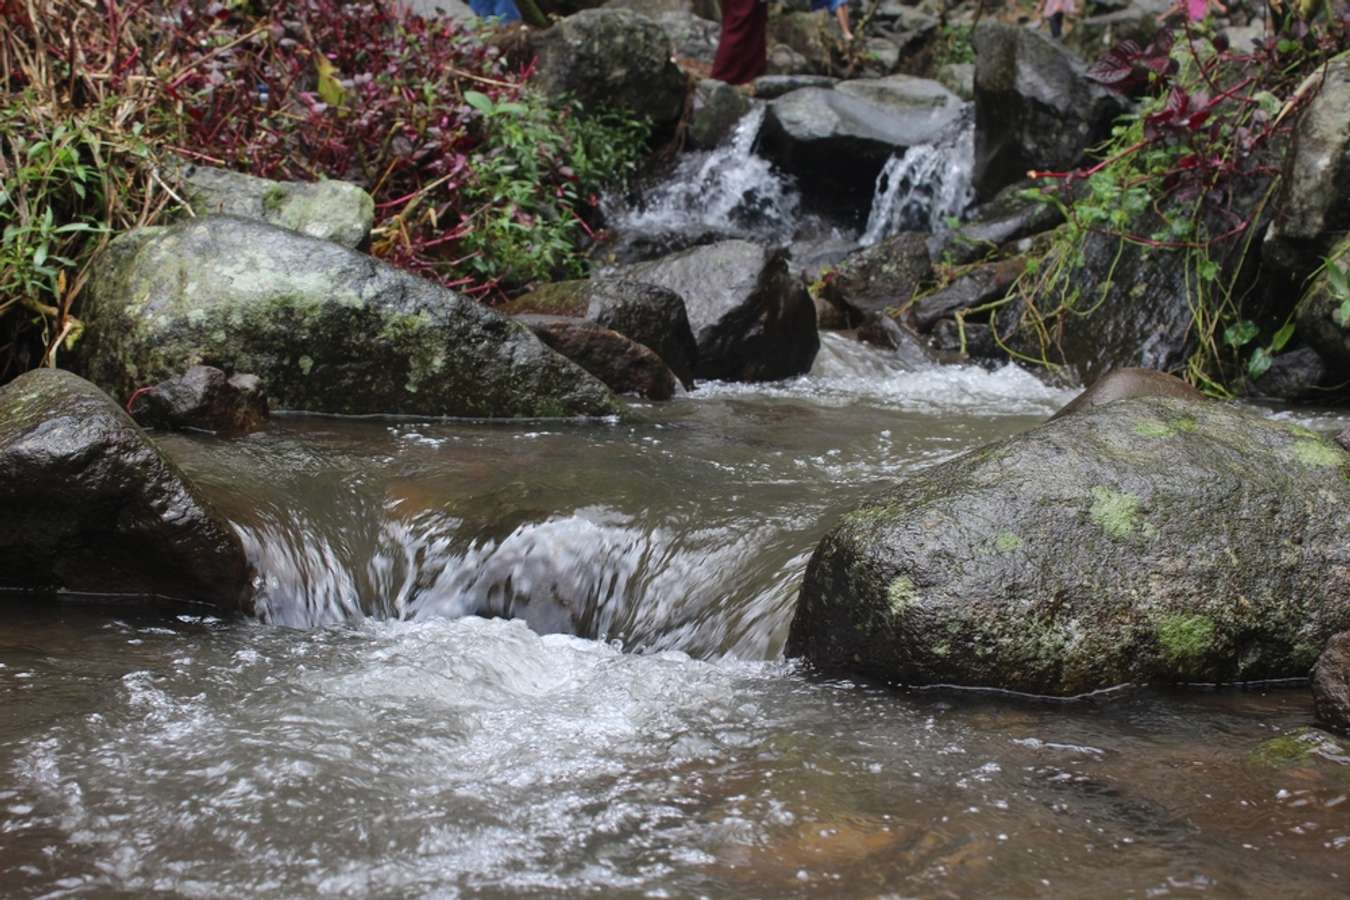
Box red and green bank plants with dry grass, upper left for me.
[0,0,648,382]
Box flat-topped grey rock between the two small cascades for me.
[760,78,963,227]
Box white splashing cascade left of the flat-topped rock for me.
[605,105,801,253]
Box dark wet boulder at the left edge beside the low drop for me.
[0,368,252,613]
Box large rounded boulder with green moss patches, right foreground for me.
[788,397,1350,696]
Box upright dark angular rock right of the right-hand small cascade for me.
[975,22,1126,198]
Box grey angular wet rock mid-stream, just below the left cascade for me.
[618,240,821,382]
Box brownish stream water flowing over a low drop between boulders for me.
[0,336,1350,897]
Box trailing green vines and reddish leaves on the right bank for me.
[999,4,1350,395]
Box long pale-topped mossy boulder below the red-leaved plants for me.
[81,216,618,417]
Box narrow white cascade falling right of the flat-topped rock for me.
[859,121,975,247]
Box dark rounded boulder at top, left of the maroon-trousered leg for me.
[529,9,686,131]
